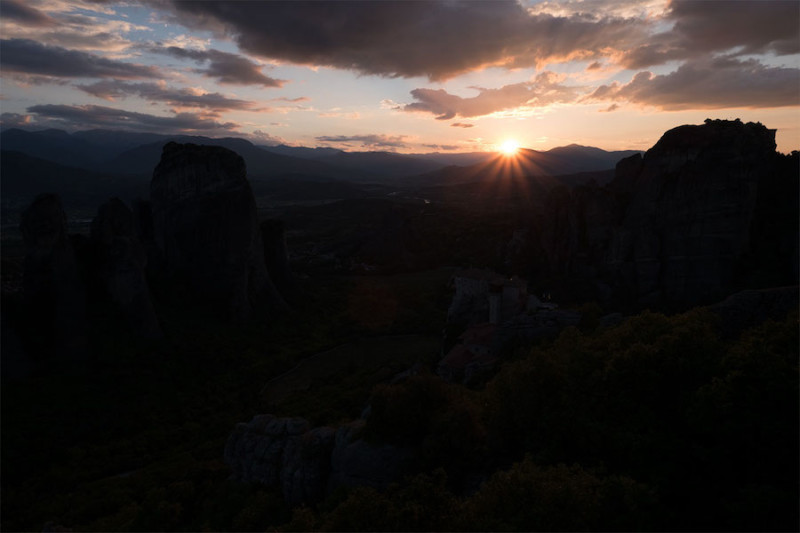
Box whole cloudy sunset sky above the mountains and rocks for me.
[0,0,800,153]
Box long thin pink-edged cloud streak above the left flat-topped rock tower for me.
[77,80,257,111]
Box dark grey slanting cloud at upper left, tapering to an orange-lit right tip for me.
[149,46,286,87]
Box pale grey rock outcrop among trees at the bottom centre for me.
[225,415,409,505]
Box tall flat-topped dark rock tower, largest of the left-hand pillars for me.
[150,143,283,320]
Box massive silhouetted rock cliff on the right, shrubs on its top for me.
[538,120,798,307]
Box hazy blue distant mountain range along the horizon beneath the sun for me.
[0,128,636,211]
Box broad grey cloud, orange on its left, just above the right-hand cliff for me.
[586,58,800,111]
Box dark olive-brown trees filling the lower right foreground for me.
[284,310,799,531]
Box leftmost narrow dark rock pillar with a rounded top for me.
[20,194,86,358]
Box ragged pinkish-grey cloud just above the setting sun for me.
[403,71,578,120]
